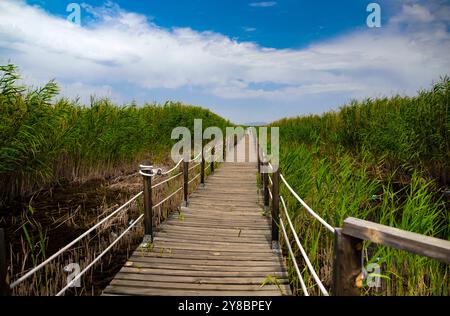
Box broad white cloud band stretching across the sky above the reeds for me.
[0,0,450,119]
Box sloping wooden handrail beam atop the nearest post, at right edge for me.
[342,217,450,264]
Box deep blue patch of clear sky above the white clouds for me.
[27,0,391,48]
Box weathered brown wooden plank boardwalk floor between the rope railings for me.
[103,136,291,296]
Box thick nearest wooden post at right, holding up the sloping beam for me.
[332,228,363,296]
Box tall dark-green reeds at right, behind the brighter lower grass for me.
[273,77,450,185]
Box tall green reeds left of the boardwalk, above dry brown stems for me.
[0,65,230,202]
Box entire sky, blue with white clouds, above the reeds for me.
[0,0,450,123]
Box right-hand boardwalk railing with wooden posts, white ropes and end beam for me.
[258,146,450,296]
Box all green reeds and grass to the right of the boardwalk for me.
[273,78,450,295]
